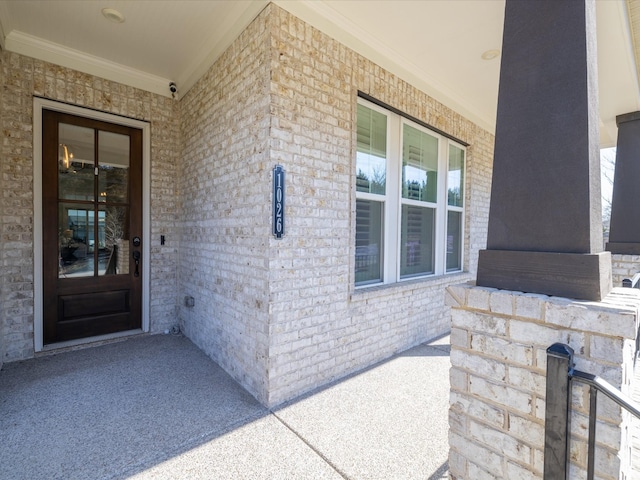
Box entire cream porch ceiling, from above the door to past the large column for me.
[0,0,640,146]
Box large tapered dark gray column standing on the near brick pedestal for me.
[477,0,612,300]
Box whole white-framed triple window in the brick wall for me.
[355,99,465,286]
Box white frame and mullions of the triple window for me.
[353,97,467,289]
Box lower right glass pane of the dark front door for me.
[98,205,129,275]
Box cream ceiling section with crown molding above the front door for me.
[0,0,268,96]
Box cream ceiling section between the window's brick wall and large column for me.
[274,0,504,132]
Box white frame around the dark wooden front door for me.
[33,97,151,352]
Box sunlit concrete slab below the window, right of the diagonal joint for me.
[274,338,450,480]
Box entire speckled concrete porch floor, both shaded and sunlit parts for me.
[0,335,450,480]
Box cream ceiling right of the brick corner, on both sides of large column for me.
[274,0,640,147]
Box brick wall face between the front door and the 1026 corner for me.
[178,10,277,402]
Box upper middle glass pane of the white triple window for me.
[402,125,438,203]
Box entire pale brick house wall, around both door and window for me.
[0,5,493,405]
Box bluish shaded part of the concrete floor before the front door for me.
[0,336,268,480]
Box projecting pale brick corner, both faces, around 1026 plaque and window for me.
[179,5,493,405]
